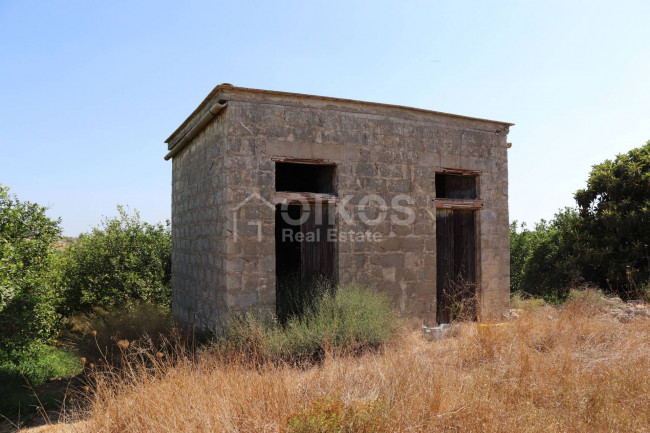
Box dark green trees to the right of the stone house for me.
[510,141,650,302]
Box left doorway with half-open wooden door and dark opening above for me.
[271,157,339,321]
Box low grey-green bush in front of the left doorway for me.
[218,286,398,361]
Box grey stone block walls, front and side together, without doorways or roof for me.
[172,88,510,326]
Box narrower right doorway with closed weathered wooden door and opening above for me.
[432,167,484,324]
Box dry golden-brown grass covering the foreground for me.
[40,294,650,433]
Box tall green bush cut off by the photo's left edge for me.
[0,185,61,354]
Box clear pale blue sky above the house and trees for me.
[0,0,650,236]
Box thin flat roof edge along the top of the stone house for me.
[165,83,514,149]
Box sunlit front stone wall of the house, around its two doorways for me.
[215,90,509,324]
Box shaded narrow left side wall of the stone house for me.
[172,112,228,329]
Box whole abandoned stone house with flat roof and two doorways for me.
[165,84,512,328]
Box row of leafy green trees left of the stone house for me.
[0,193,171,362]
